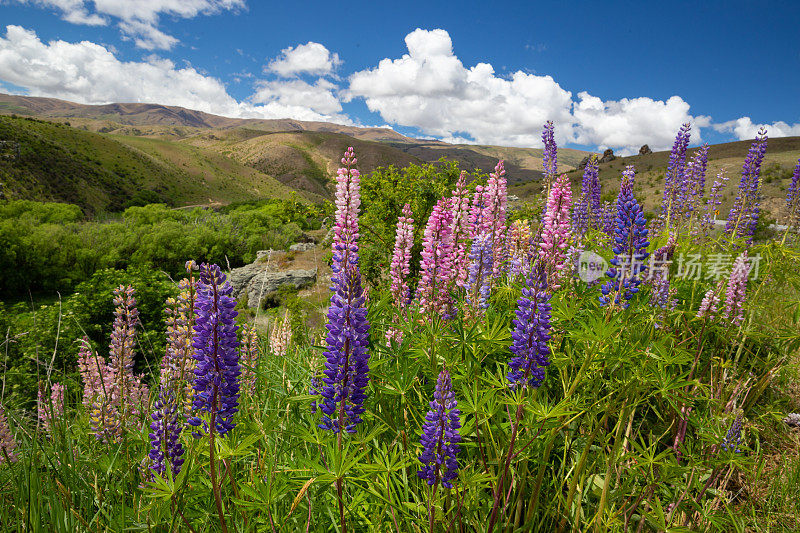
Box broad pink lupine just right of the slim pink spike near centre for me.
[417,198,454,316]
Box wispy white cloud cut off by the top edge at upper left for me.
[12,0,245,50]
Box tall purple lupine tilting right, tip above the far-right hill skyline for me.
[725,127,767,237]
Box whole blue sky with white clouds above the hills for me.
[0,0,800,153]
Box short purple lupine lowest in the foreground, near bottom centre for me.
[417,368,461,488]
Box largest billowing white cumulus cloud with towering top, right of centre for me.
[346,29,572,146]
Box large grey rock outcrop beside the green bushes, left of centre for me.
[230,260,317,308]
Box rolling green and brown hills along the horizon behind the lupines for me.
[0,94,800,221]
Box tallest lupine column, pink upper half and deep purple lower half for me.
[319,148,369,433]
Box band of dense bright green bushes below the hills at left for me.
[0,200,325,297]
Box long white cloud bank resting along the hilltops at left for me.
[0,25,352,124]
